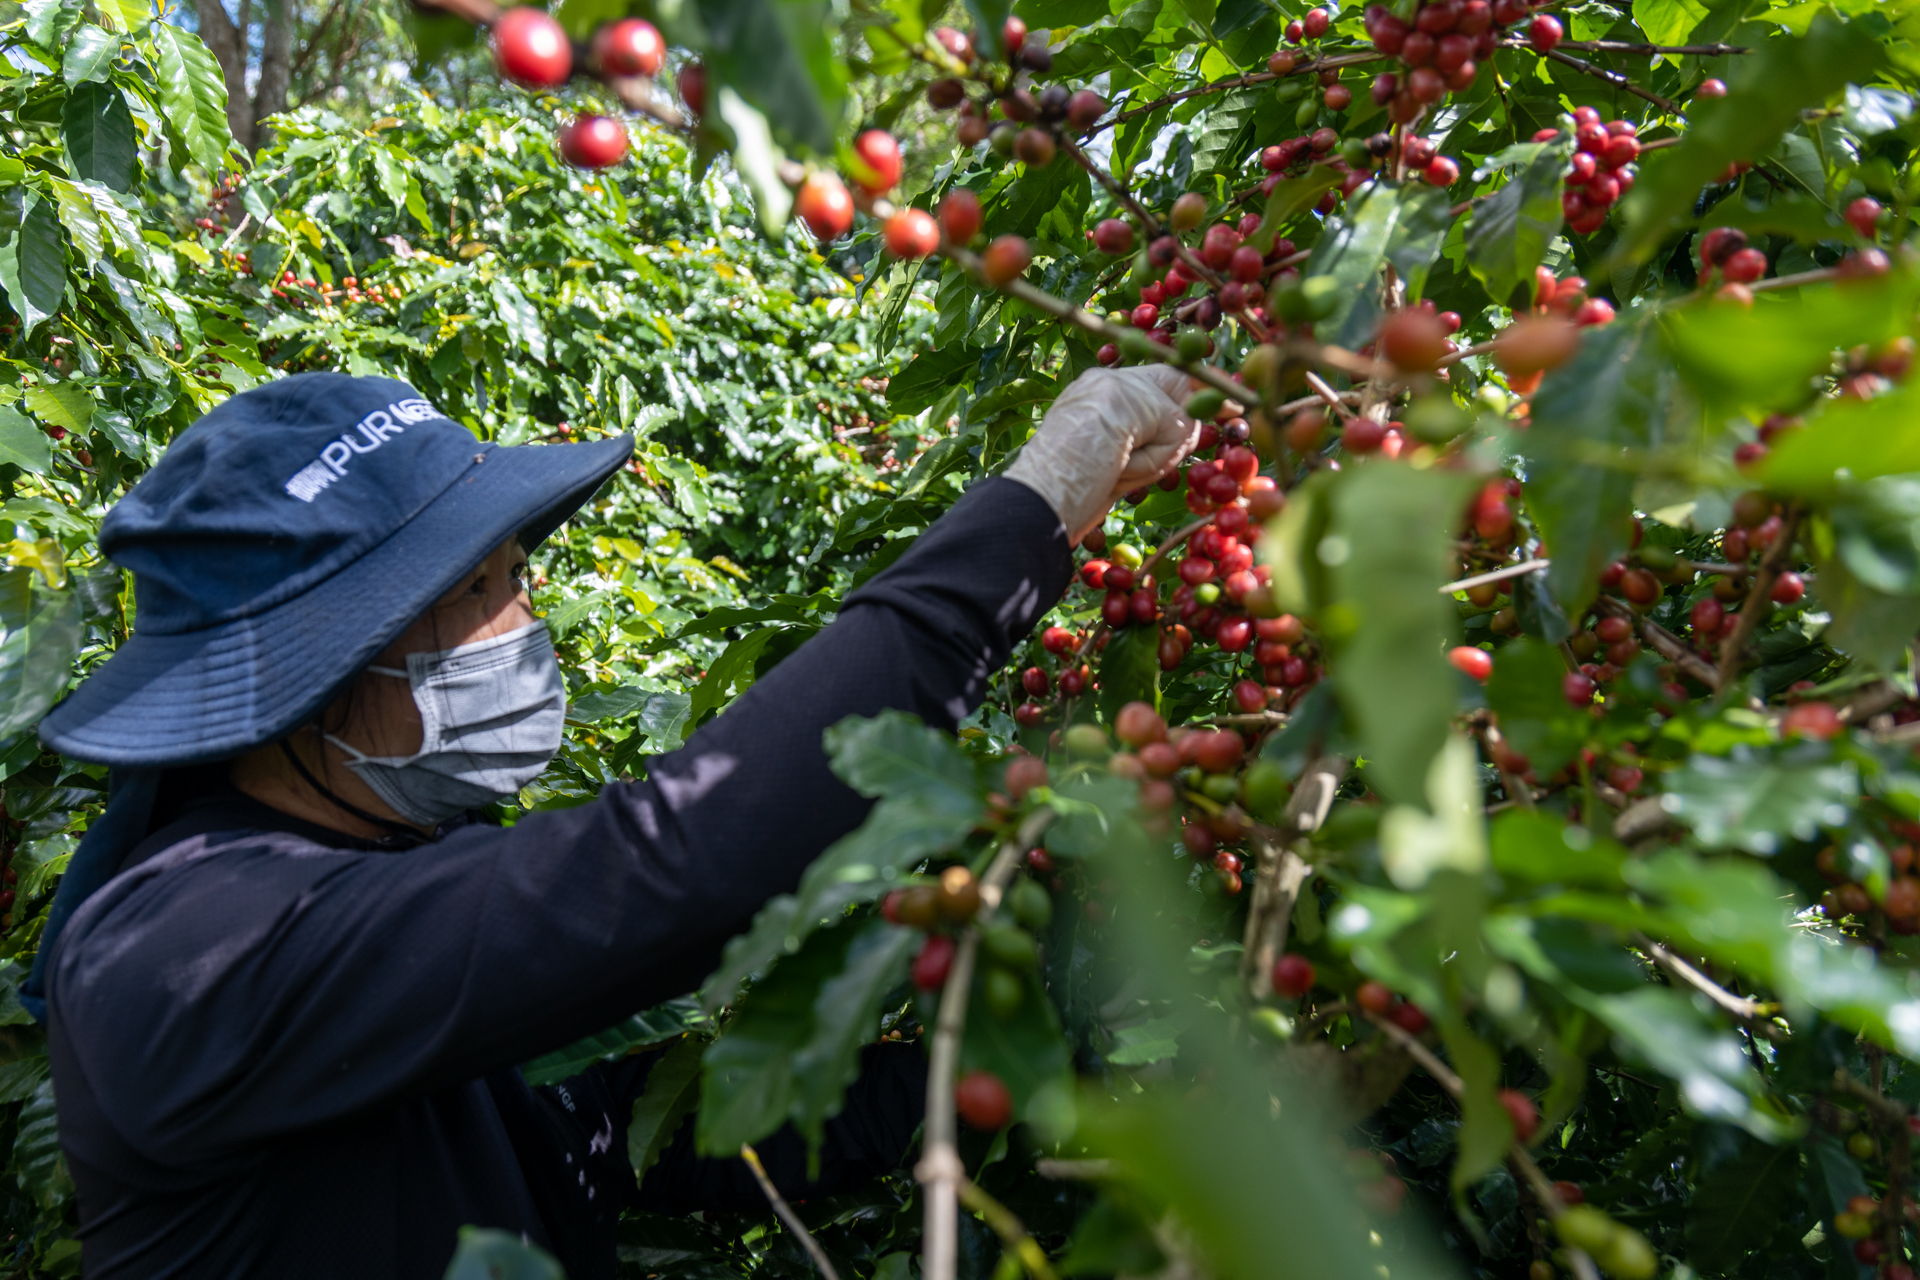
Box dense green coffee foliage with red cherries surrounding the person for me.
[0,0,1920,1280]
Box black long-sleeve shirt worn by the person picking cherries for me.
[48,480,1071,1280]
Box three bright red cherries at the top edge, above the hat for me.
[493,6,675,169]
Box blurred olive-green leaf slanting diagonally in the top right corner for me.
[1615,12,1885,261]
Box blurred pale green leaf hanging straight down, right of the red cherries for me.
[1304,464,1466,804]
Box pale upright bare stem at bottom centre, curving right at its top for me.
[914,810,1054,1280]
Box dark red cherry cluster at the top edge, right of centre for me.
[1363,0,1563,125]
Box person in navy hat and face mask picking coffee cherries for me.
[25,368,1198,1280]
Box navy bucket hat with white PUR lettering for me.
[40,374,634,770]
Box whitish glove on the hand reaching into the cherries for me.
[1006,365,1200,543]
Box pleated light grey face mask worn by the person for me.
[326,622,566,827]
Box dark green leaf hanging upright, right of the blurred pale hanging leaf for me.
[1520,317,1672,614]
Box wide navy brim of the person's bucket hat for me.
[40,436,634,768]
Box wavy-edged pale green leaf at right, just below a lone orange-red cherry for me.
[1663,745,1860,854]
